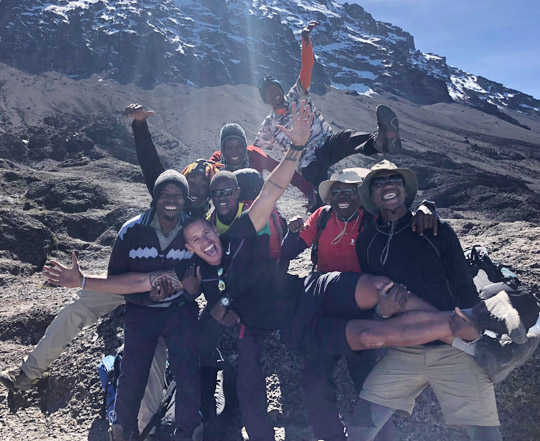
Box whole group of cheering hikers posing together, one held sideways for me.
[0,23,532,441]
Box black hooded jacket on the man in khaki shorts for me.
[356,213,480,311]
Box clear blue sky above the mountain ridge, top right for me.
[350,0,540,99]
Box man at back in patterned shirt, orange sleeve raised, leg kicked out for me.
[253,21,401,211]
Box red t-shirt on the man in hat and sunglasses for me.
[300,207,364,273]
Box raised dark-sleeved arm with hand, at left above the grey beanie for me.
[126,104,165,194]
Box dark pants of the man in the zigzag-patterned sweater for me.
[115,302,201,439]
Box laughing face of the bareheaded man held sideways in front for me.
[184,219,223,265]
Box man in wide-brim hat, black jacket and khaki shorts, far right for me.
[349,161,502,441]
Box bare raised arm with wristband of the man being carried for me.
[247,101,313,231]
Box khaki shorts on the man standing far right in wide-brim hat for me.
[360,345,500,426]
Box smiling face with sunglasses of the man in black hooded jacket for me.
[370,170,407,214]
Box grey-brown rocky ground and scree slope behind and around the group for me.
[0,65,540,441]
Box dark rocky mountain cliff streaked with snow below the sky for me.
[0,0,540,124]
